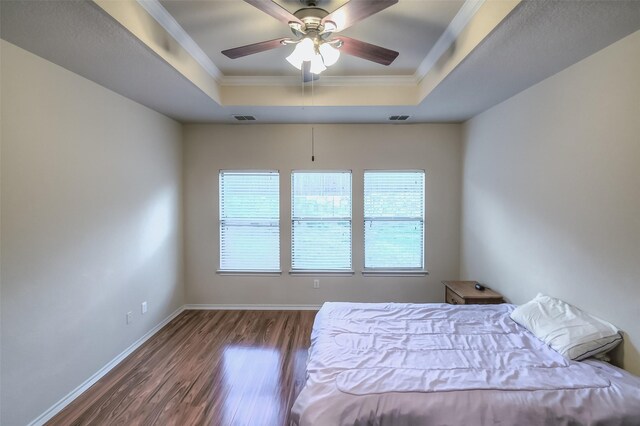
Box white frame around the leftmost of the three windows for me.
[216,169,282,276]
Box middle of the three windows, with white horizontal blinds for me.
[291,172,351,271]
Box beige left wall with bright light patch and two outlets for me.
[0,41,184,426]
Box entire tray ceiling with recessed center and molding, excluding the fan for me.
[0,0,640,124]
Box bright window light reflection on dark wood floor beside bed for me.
[223,346,283,425]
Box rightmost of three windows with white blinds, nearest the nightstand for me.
[364,171,424,270]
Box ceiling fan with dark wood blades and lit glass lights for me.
[222,0,398,83]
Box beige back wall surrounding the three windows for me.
[184,124,461,305]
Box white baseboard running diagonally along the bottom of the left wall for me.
[28,305,185,426]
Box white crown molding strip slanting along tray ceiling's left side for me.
[136,0,224,82]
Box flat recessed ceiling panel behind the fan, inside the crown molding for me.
[160,0,464,76]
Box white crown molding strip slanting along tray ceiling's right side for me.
[414,0,486,83]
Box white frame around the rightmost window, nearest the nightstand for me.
[362,169,429,276]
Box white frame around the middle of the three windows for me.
[289,169,354,276]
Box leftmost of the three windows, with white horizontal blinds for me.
[220,171,280,272]
